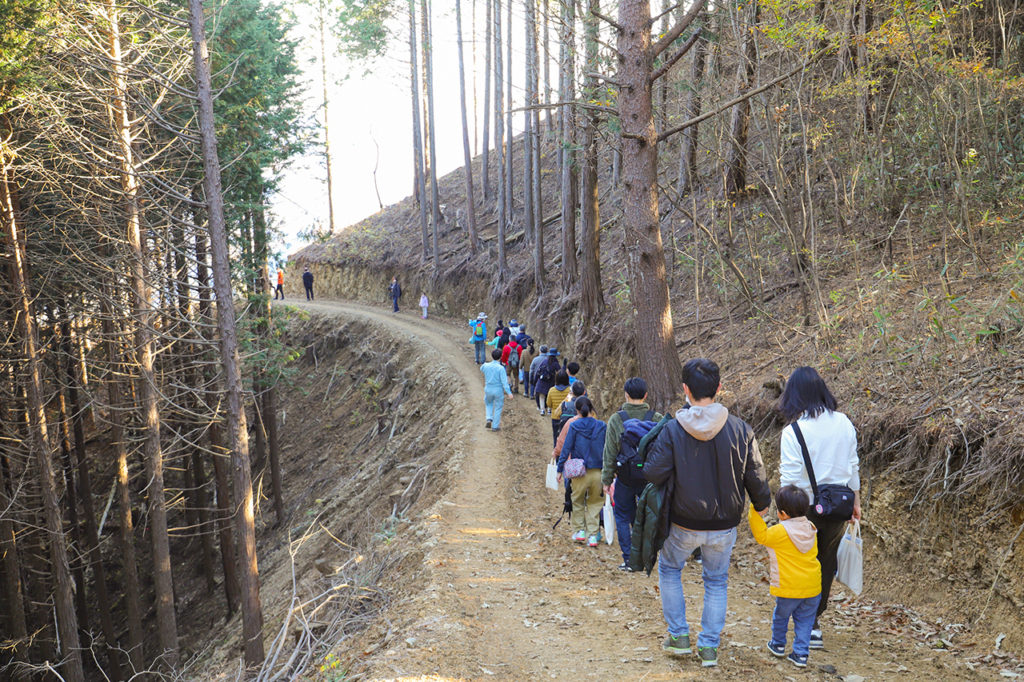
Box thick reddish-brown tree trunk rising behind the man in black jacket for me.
[616,0,705,409]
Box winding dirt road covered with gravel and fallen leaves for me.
[284,301,999,681]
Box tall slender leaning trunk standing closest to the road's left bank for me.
[188,0,263,666]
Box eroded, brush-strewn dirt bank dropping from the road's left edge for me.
[193,313,465,679]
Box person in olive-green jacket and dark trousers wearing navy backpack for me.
[598,377,662,570]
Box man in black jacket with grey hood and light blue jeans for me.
[643,358,771,668]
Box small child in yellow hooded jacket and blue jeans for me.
[749,485,821,668]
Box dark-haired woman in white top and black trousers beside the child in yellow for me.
[778,367,860,649]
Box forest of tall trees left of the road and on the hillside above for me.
[0,0,1024,681]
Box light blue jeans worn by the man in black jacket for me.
[657,524,736,647]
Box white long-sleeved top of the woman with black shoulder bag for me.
[778,410,860,502]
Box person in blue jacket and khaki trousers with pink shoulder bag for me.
[558,395,605,547]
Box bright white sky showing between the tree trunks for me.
[271,0,544,257]
